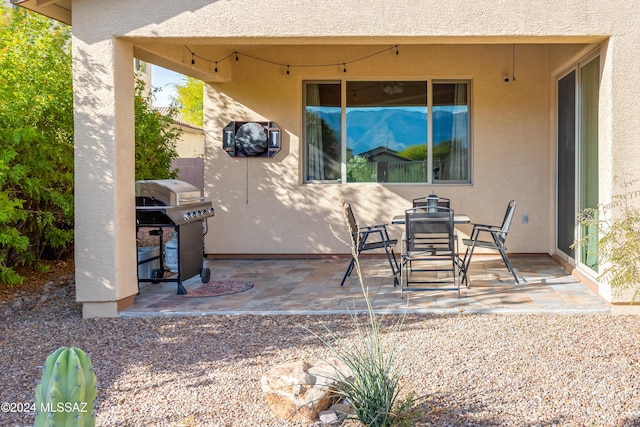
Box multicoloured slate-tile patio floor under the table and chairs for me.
[120,254,611,317]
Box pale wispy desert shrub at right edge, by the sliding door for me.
[573,182,640,303]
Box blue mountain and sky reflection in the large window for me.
[322,109,467,154]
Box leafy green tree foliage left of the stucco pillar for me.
[0,6,73,283]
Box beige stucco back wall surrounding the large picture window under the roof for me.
[205,45,579,254]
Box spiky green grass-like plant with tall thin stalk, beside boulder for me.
[323,200,414,427]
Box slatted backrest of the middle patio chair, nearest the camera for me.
[405,206,455,252]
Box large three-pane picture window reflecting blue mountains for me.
[304,80,469,183]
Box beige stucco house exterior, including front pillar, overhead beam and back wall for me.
[18,0,640,317]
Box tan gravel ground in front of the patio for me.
[0,282,640,427]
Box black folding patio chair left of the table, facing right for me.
[340,202,400,287]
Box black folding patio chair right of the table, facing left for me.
[462,200,520,286]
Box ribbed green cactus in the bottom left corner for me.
[34,347,96,427]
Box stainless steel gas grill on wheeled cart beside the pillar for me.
[136,179,215,295]
